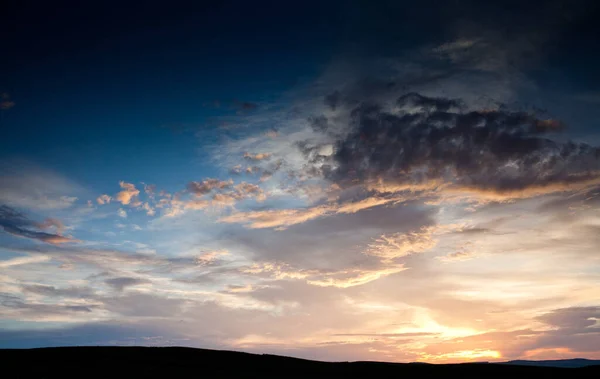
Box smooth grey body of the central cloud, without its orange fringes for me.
[219,203,435,270]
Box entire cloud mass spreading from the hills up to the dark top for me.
[0,2,600,361]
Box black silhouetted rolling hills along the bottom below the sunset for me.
[0,347,600,379]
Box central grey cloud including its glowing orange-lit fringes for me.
[219,205,436,288]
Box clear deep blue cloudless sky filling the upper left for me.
[0,2,340,188]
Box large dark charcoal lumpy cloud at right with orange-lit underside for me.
[301,93,600,199]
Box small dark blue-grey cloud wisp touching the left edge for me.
[0,205,76,244]
